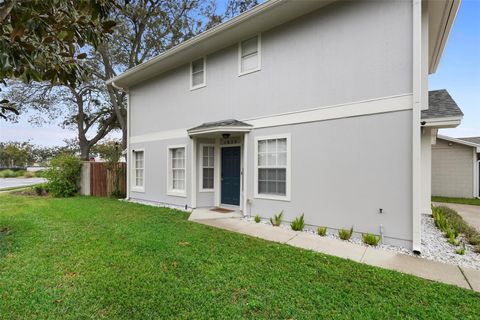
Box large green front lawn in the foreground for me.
[0,195,480,319]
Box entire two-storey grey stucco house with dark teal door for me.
[108,0,461,251]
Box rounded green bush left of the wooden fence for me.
[45,154,82,197]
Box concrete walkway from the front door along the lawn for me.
[189,209,480,292]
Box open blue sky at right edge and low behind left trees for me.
[0,0,480,146]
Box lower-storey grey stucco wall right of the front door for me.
[248,111,412,246]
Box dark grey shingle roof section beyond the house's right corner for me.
[422,89,463,119]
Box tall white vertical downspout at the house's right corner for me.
[412,0,422,254]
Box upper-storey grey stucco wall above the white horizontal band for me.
[130,1,412,136]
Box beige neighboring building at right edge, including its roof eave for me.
[432,135,480,198]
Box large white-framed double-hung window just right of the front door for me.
[255,135,290,200]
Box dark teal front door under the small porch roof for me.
[221,147,240,206]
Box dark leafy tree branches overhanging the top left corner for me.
[0,0,115,118]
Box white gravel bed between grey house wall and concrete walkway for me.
[244,215,480,270]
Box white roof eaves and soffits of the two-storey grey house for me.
[107,0,460,88]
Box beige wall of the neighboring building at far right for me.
[432,138,474,198]
